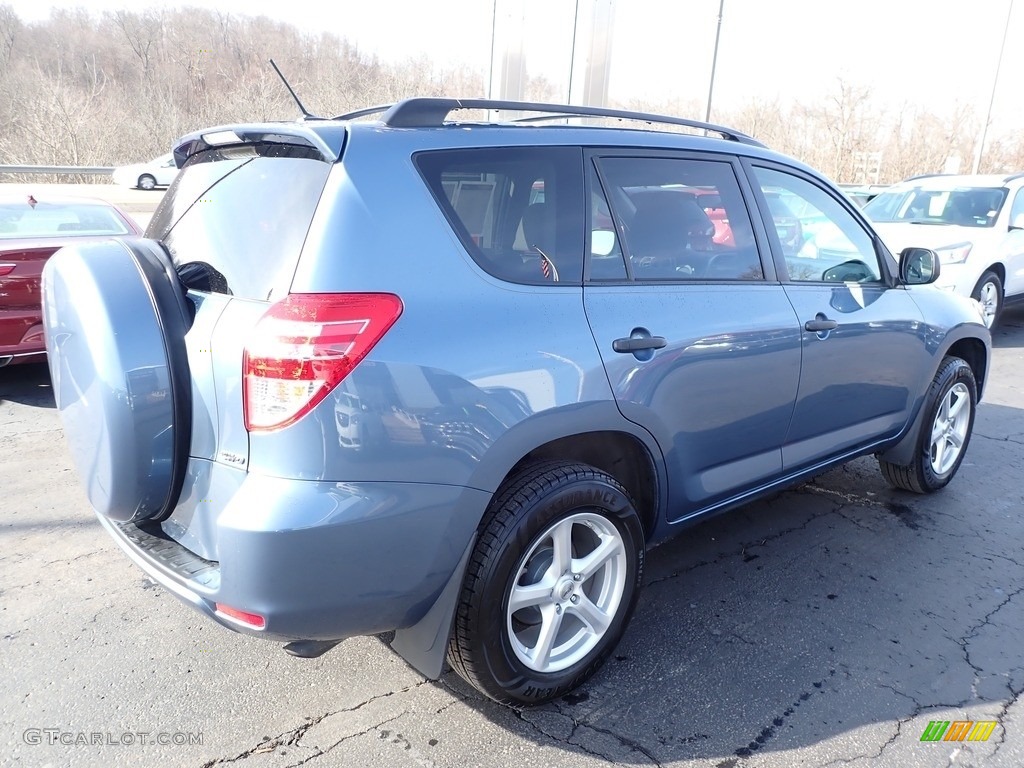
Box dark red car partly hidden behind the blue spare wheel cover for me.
[0,195,142,367]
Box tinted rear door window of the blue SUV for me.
[591,157,763,281]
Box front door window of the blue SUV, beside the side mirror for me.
[754,168,882,283]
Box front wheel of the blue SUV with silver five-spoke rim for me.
[879,357,978,494]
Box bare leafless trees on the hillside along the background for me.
[0,5,1024,183]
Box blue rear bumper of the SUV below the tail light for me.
[100,459,489,642]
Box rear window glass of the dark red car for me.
[0,202,129,240]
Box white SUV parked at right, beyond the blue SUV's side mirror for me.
[864,173,1024,328]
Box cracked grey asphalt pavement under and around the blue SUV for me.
[0,310,1024,768]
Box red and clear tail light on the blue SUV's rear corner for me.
[242,293,402,431]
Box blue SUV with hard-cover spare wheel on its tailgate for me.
[44,98,990,703]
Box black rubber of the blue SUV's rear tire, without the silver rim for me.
[476,478,644,702]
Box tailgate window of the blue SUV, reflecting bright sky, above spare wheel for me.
[145,144,331,300]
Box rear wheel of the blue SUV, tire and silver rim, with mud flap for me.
[447,462,644,705]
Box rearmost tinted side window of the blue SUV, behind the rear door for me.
[416,146,585,285]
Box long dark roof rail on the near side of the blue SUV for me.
[336,96,764,146]
